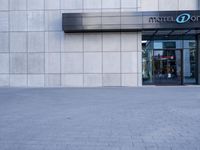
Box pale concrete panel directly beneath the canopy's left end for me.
[61,33,83,52]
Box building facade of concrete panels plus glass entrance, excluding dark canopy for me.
[0,0,200,87]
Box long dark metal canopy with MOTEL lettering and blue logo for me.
[62,11,200,33]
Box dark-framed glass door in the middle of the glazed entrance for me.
[153,49,183,85]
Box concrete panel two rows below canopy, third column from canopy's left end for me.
[103,52,121,73]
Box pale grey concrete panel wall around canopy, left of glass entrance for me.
[0,0,142,87]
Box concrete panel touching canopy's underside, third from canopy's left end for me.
[103,33,120,51]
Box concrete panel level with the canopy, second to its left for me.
[28,11,44,31]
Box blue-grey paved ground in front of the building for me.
[0,86,200,150]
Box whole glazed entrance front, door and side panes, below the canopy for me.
[142,40,197,84]
